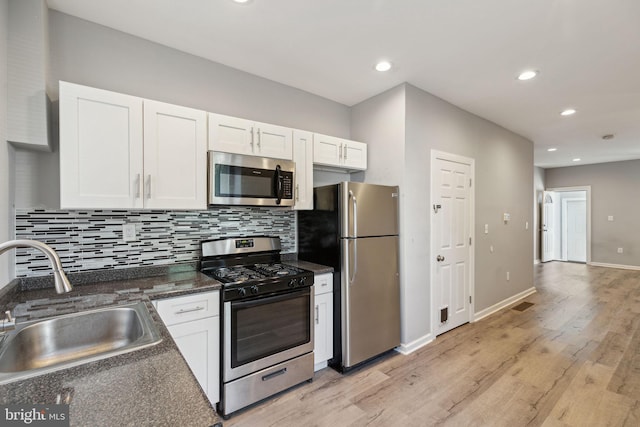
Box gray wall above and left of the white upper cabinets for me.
[16,11,350,209]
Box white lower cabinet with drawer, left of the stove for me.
[153,291,220,406]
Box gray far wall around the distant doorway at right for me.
[545,160,640,267]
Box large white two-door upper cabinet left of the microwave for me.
[60,82,207,209]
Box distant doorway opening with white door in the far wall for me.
[541,186,591,263]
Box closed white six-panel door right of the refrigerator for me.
[431,157,472,335]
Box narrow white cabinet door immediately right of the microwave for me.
[293,130,313,210]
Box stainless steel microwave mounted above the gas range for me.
[208,151,295,206]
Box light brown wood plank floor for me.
[224,262,640,427]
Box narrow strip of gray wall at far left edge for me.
[0,0,13,287]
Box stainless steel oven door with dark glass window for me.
[223,287,313,382]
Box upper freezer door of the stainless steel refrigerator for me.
[340,182,399,237]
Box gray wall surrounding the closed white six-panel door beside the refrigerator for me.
[352,84,533,345]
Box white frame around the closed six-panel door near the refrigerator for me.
[429,150,476,339]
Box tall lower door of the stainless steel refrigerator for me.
[340,236,400,368]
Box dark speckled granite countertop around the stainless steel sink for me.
[0,271,221,426]
